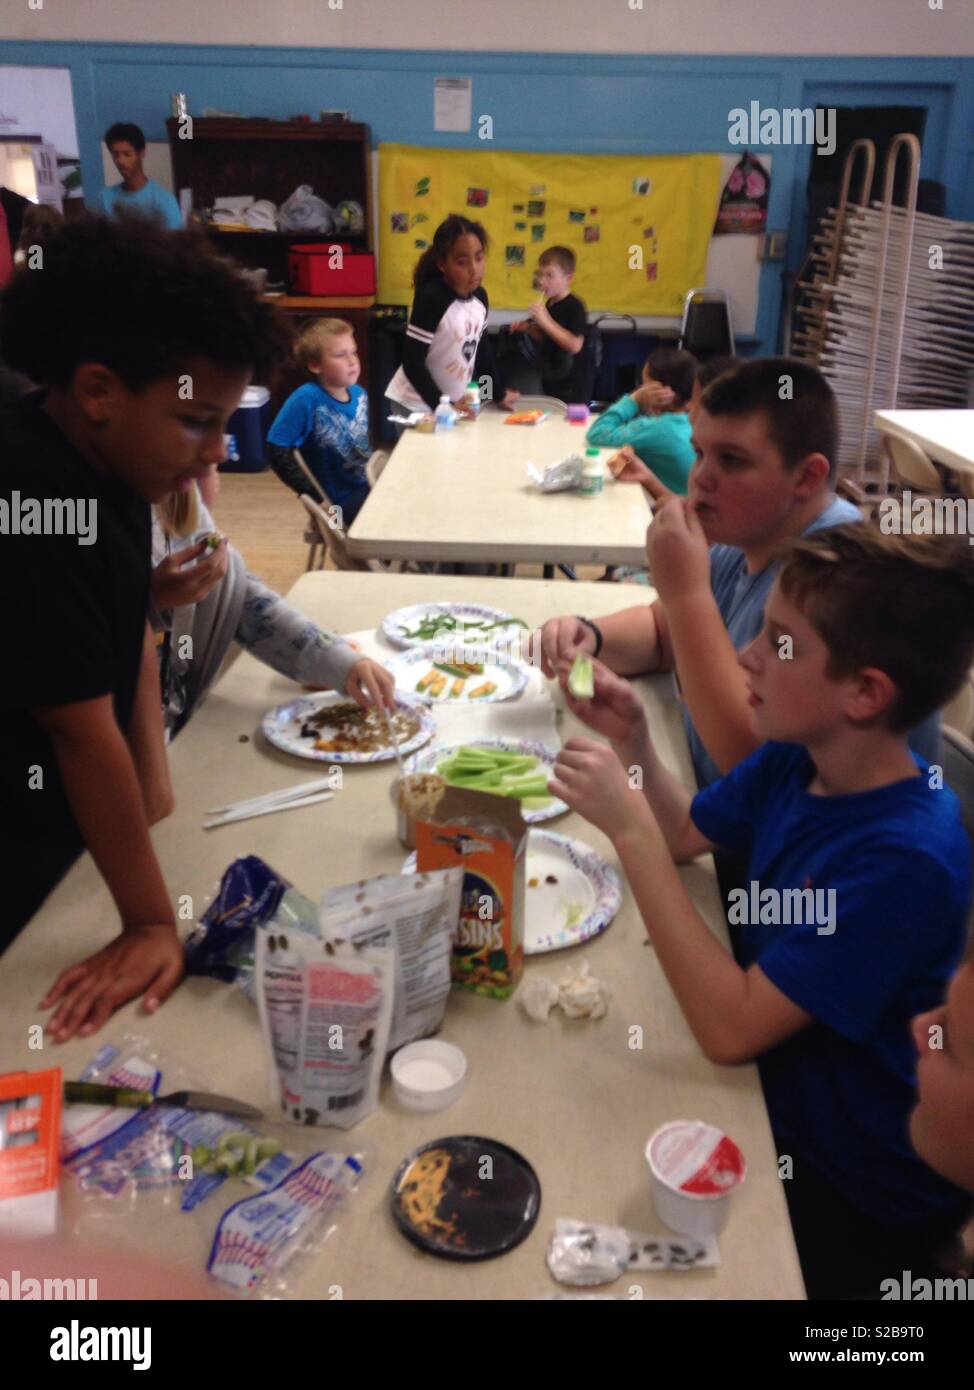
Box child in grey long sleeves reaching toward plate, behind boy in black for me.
[149,468,395,735]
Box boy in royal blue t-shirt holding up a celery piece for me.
[552,523,974,1298]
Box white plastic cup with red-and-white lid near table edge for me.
[646,1120,748,1237]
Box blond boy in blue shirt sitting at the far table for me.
[267,318,368,530]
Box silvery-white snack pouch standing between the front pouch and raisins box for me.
[318,869,463,1051]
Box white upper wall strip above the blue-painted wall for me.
[0,0,974,57]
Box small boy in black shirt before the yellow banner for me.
[509,246,588,400]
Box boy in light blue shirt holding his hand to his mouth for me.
[540,357,939,787]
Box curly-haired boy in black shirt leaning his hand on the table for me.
[0,218,282,1041]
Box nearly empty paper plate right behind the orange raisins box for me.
[403,830,622,955]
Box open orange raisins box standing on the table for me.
[415,787,528,999]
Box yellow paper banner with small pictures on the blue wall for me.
[379,145,720,316]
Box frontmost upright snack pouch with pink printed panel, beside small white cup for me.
[256,927,396,1129]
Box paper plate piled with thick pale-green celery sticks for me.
[406,738,568,826]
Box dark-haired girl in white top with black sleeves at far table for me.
[386,213,520,414]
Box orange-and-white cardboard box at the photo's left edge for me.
[0,1068,61,1236]
